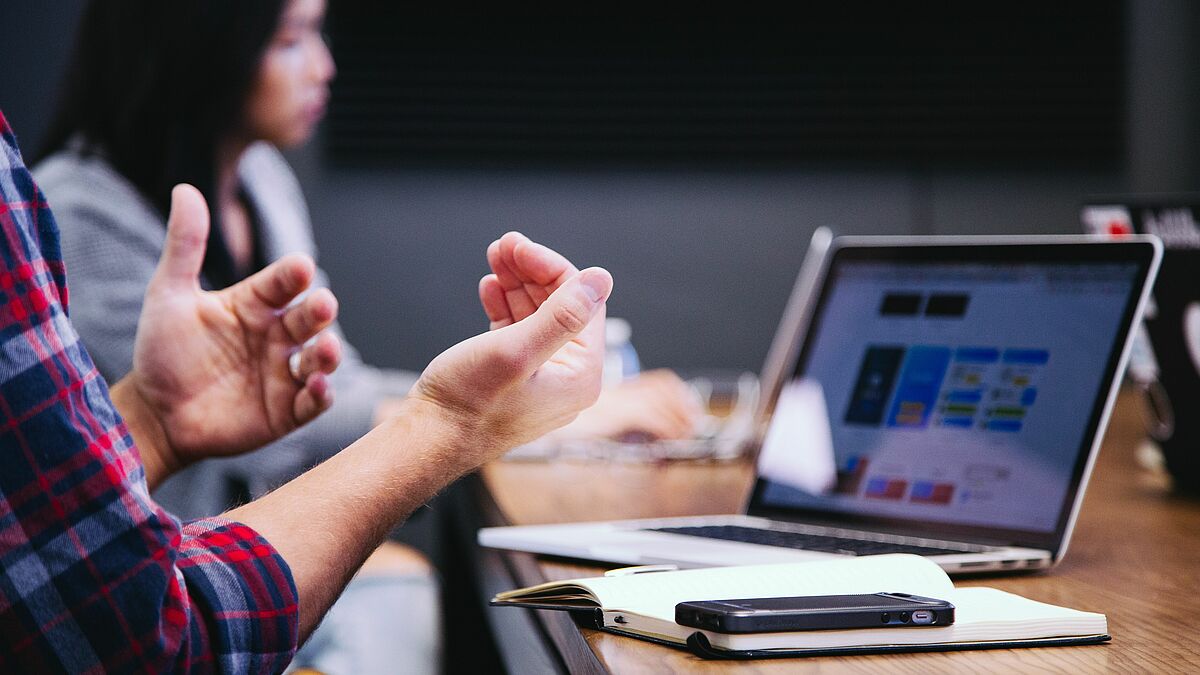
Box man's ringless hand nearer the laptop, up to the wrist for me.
[410,233,612,470]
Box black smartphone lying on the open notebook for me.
[676,593,954,633]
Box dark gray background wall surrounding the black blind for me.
[0,0,1200,370]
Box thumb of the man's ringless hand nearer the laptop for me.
[502,267,612,370]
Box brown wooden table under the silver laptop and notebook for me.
[480,395,1200,673]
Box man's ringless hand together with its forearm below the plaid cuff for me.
[228,234,612,639]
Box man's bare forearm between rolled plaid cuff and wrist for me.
[226,399,474,640]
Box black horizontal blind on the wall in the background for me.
[325,0,1124,167]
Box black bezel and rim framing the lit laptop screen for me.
[746,237,1160,557]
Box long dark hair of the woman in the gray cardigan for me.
[37,0,284,287]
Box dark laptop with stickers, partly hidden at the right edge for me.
[1080,193,1200,492]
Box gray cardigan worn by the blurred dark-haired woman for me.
[34,143,416,518]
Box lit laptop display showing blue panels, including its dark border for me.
[752,239,1152,548]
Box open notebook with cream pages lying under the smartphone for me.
[492,555,1110,657]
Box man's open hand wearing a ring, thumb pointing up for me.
[113,185,341,484]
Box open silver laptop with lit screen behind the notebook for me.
[479,234,1162,573]
